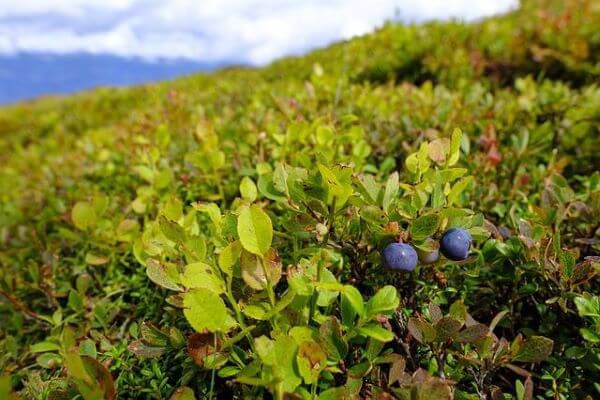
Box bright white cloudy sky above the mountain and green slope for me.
[0,0,517,64]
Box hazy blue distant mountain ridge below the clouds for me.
[0,53,227,104]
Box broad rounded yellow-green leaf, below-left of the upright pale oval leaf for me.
[183,289,229,333]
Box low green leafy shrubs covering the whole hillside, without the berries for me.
[0,0,600,400]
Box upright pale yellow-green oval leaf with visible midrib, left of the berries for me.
[237,205,273,256]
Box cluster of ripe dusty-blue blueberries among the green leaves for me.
[383,228,473,271]
